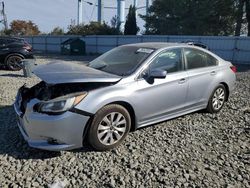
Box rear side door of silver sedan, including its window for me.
[184,48,218,107]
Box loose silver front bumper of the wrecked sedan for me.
[14,95,90,151]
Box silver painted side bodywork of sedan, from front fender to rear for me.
[77,45,235,128]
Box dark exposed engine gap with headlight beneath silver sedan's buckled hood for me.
[17,81,115,115]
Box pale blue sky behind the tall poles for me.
[0,0,148,33]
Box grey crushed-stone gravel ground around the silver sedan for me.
[0,56,250,187]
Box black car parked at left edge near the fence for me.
[0,37,33,70]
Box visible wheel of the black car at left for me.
[5,54,24,71]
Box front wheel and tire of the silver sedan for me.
[87,104,131,151]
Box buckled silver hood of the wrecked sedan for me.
[33,61,121,84]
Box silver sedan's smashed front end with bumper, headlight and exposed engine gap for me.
[14,81,115,151]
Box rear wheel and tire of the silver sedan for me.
[206,84,228,113]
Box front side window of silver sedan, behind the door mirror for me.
[150,49,183,73]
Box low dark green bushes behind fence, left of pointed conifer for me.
[67,22,121,35]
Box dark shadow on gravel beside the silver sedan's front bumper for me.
[0,106,61,159]
